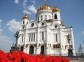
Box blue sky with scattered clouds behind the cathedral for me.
[0,0,84,52]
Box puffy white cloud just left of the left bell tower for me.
[6,19,21,33]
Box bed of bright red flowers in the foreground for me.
[0,50,70,62]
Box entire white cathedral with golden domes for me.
[11,4,75,56]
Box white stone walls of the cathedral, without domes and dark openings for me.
[17,8,75,55]
